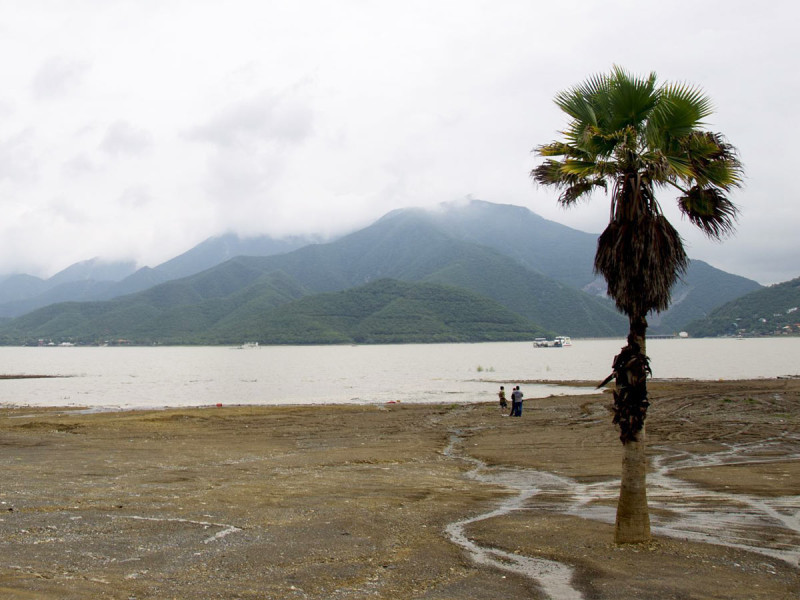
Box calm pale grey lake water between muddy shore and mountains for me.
[0,338,800,408]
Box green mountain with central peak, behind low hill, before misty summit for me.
[0,211,626,343]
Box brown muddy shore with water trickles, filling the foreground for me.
[0,379,800,600]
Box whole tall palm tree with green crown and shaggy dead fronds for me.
[531,66,743,543]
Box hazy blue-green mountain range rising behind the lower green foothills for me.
[0,200,760,337]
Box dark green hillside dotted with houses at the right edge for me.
[686,277,800,337]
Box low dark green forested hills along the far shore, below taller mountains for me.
[3,274,547,344]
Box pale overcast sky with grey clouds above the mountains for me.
[0,0,800,284]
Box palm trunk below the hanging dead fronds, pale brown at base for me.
[614,317,650,544]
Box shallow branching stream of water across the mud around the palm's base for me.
[445,432,800,599]
